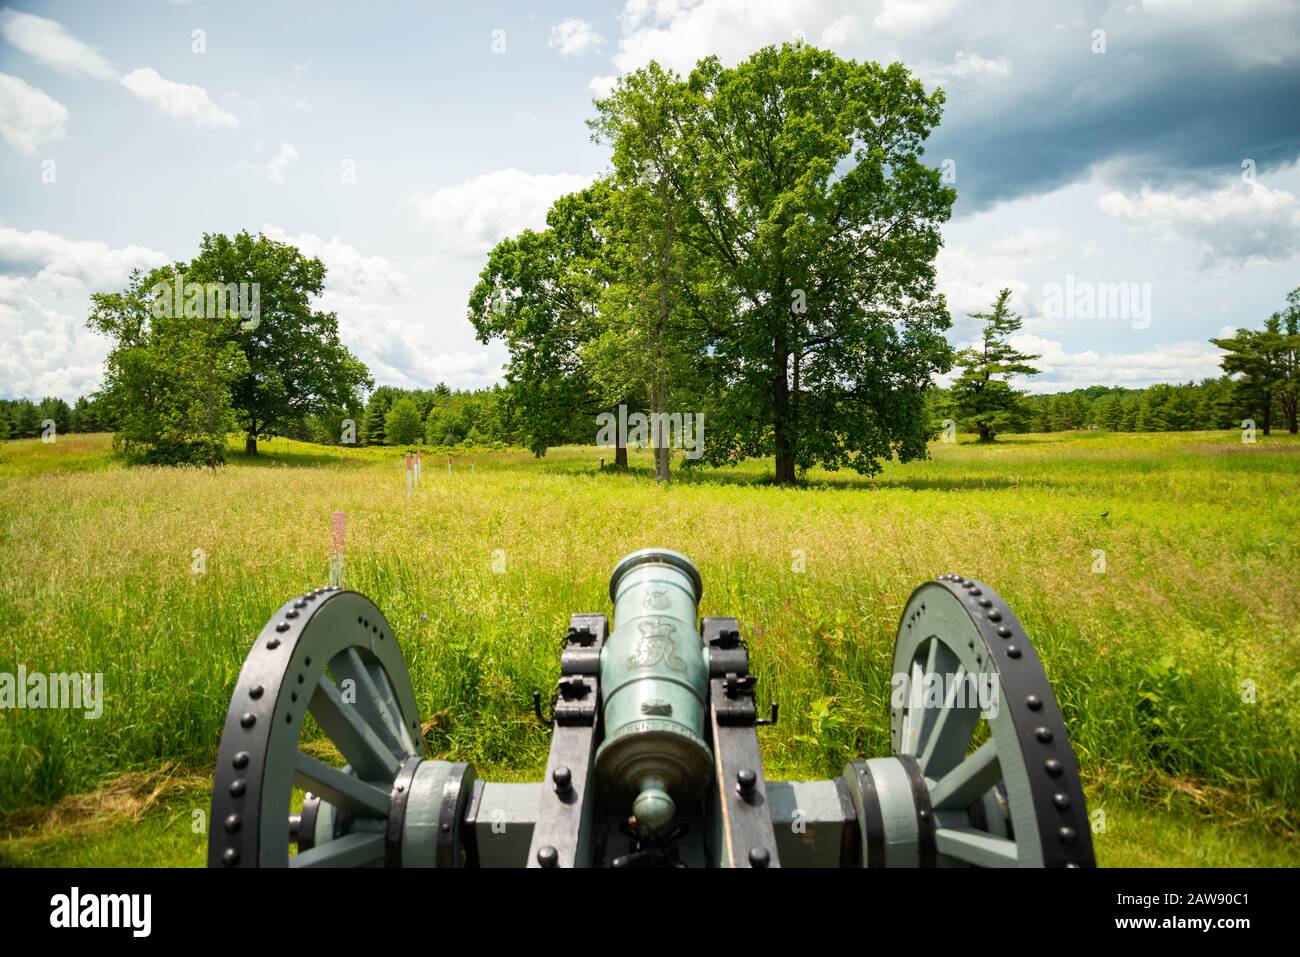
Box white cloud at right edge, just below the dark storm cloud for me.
[1099,182,1300,267]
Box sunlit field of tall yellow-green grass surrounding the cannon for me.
[0,432,1300,866]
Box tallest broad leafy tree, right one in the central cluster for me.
[660,43,956,484]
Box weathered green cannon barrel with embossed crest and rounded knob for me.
[595,549,712,835]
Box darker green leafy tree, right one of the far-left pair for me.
[186,231,373,454]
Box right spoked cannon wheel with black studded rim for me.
[889,575,1095,867]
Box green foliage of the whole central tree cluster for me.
[469,43,956,482]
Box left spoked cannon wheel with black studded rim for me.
[208,588,424,867]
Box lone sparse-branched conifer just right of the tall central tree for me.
[952,289,1040,442]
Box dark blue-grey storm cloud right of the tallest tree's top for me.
[909,4,1300,213]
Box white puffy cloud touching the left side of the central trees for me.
[407,169,592,255]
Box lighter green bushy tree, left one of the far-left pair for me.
[88,264,248,464]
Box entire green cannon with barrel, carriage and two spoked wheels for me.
[208,549,1095,869]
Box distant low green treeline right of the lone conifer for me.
[931,376,1287,432]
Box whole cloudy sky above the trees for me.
[0,0,1300,400]
